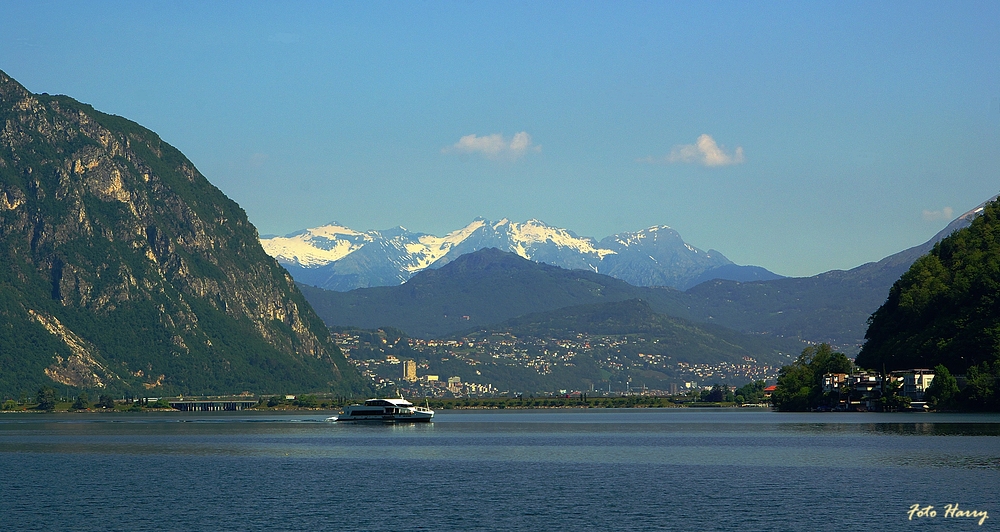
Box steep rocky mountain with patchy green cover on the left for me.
[0,72,361,393]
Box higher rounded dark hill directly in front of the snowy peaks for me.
[301,249,686,337]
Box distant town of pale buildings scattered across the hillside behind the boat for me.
[333,331,779,397]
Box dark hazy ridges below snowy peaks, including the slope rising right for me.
[300,195,985,354]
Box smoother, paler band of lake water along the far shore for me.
[0,409,1000,468]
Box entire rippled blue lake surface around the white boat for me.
[0,409,1000,530]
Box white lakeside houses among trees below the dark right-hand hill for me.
[823,369,934,411]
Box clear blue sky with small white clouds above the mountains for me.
[0,0,1000,275]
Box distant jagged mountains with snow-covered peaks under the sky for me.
[261,218,780,291]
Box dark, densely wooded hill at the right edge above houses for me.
[857,200,1000,411]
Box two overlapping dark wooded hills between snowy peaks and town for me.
[302,248,801,362]
